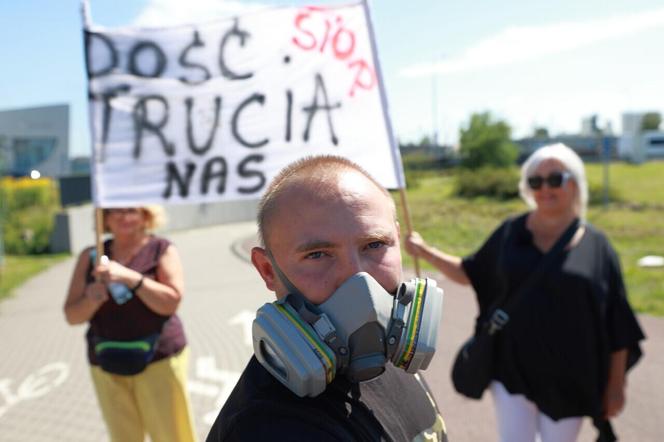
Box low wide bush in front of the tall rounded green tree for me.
[454,167,519,200]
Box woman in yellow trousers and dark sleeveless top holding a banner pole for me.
[64,207,196,442]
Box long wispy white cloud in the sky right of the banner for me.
[400,8,664,78]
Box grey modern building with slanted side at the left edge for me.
[0,104,70,178]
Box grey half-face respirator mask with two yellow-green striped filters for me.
[252,271,443,397]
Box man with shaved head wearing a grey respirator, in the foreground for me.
[207,156,446,441]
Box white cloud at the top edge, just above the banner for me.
[134,0,265,27]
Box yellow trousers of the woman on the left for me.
[90,348,196,442]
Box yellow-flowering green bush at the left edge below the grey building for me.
[0,178,59,255]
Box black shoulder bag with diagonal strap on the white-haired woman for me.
[452,219,579,399]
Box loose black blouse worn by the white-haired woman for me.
[463,214,644,420]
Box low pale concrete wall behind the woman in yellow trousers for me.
[51,200,258,255]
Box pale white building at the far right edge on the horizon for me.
[618,113,664,163]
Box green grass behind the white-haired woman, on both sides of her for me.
[394,161,664,316]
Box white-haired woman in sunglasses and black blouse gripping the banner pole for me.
[405,144,644,442]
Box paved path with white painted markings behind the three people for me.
[0,223,664,442]
